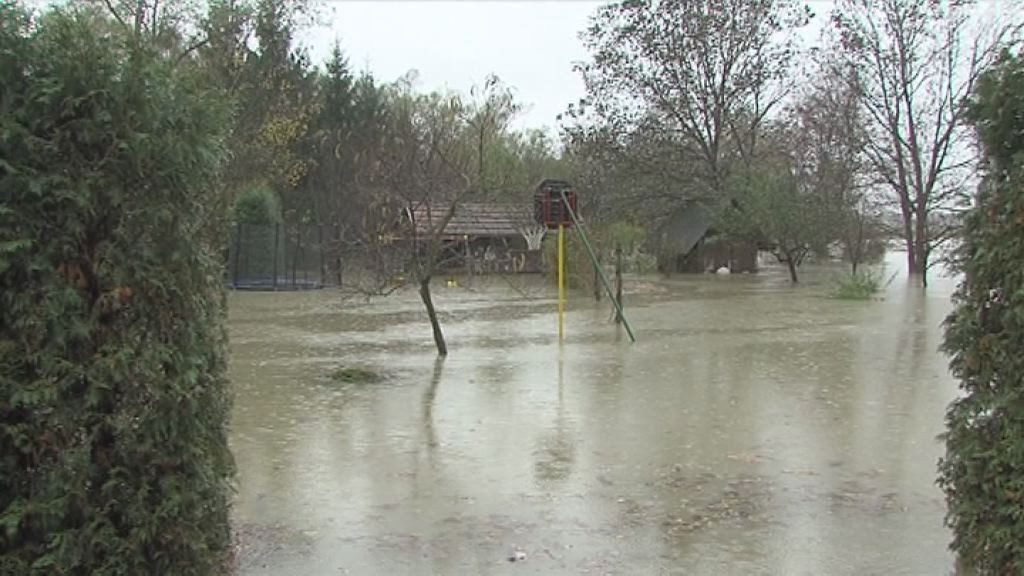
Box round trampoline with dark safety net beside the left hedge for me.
[226,223,329,290]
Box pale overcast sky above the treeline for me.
[301,0,856,133]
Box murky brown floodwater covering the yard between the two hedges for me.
[229,254,956,575]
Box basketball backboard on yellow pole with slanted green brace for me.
[534,179,637,342]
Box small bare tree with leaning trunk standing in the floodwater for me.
[349,72,519,356]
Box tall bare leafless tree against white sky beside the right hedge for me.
[833,0,1019,286]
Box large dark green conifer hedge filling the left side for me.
[0,3,232,575]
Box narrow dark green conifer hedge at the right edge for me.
[939,51,1024,574]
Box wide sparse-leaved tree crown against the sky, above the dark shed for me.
[570,0,807,196]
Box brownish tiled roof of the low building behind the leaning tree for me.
[411,202,536,238]
